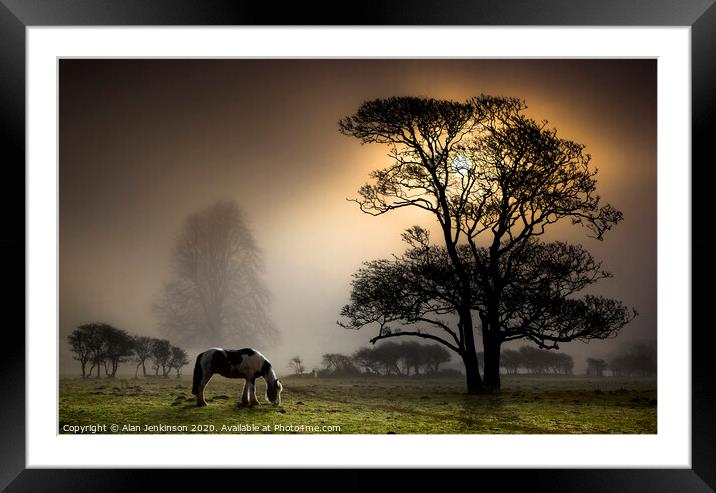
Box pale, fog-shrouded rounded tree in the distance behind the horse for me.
[154,202,278,347]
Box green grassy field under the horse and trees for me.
[59,376,657,434]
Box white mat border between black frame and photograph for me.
[26,27,691,468]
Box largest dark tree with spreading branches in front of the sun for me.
[339,95,634,393]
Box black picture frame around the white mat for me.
[0,0,716,493]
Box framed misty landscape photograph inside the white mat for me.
[58,58,656,435]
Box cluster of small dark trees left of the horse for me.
[67,323,189,378]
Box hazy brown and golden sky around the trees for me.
[59,59,656,372]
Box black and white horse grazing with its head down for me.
[191,348,283,406]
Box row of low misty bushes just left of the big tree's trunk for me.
[318,341,455,377]
